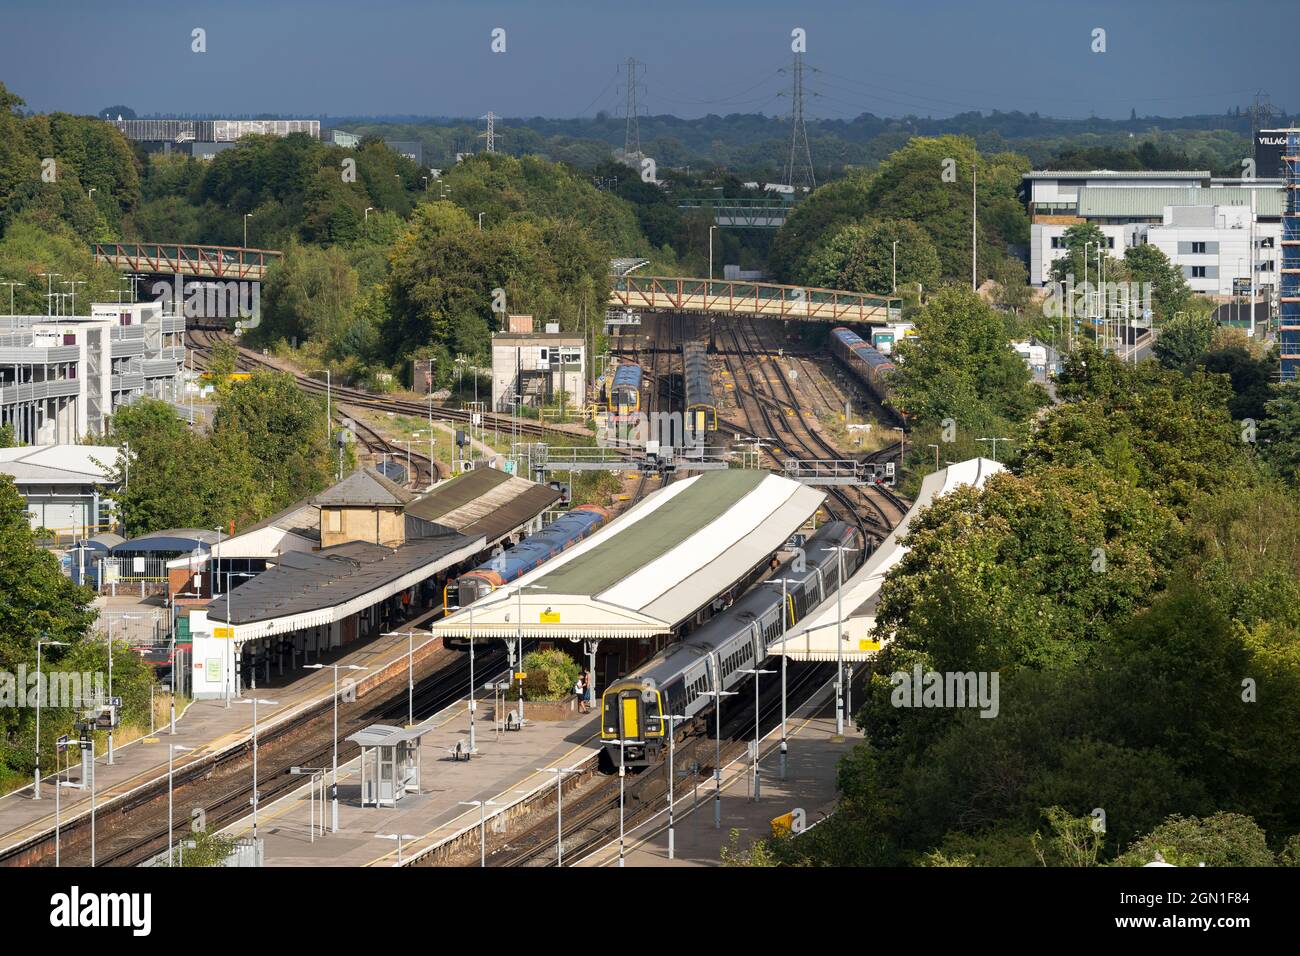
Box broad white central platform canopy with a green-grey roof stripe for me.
[429,470,826,640]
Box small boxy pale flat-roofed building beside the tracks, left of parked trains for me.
[491,325,586,411]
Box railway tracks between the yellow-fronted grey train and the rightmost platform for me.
[488,663,833,866]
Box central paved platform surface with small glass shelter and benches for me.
[224,698,599,866]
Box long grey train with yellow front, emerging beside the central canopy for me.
[601,522,866,767]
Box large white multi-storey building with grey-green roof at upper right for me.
[1024,170,1283,297]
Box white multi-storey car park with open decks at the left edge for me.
[0,302,185,445]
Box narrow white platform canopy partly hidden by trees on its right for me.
[772,458,1005,661]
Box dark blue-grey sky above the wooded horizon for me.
[0,0,1300,120]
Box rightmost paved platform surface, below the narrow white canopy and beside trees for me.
[577,686,862,866]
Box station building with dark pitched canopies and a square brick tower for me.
[185,468,559,698]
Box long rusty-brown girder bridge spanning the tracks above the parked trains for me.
[610,276,902,324]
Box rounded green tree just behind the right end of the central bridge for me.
[802,221,939,295]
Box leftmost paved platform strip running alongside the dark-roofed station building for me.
[0,621,449,848]
